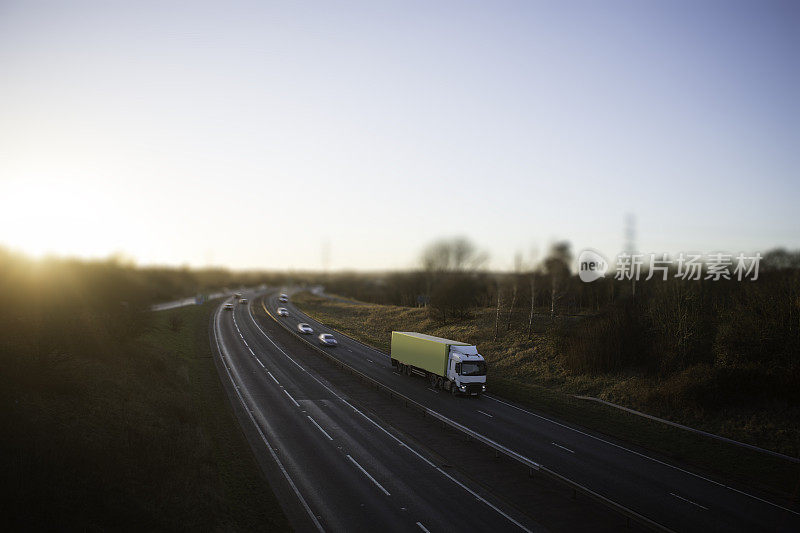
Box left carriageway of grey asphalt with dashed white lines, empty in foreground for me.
[211,293,543,532]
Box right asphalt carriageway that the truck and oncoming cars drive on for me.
[263,292,800,531]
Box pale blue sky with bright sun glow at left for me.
[0,0,800,270]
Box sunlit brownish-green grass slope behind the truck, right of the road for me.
[293,293,800,497]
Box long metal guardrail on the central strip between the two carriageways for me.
[261,297,674,533]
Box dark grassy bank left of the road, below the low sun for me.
[0,304,289,531]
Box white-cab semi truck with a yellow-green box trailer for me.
[390,331,486,396]
